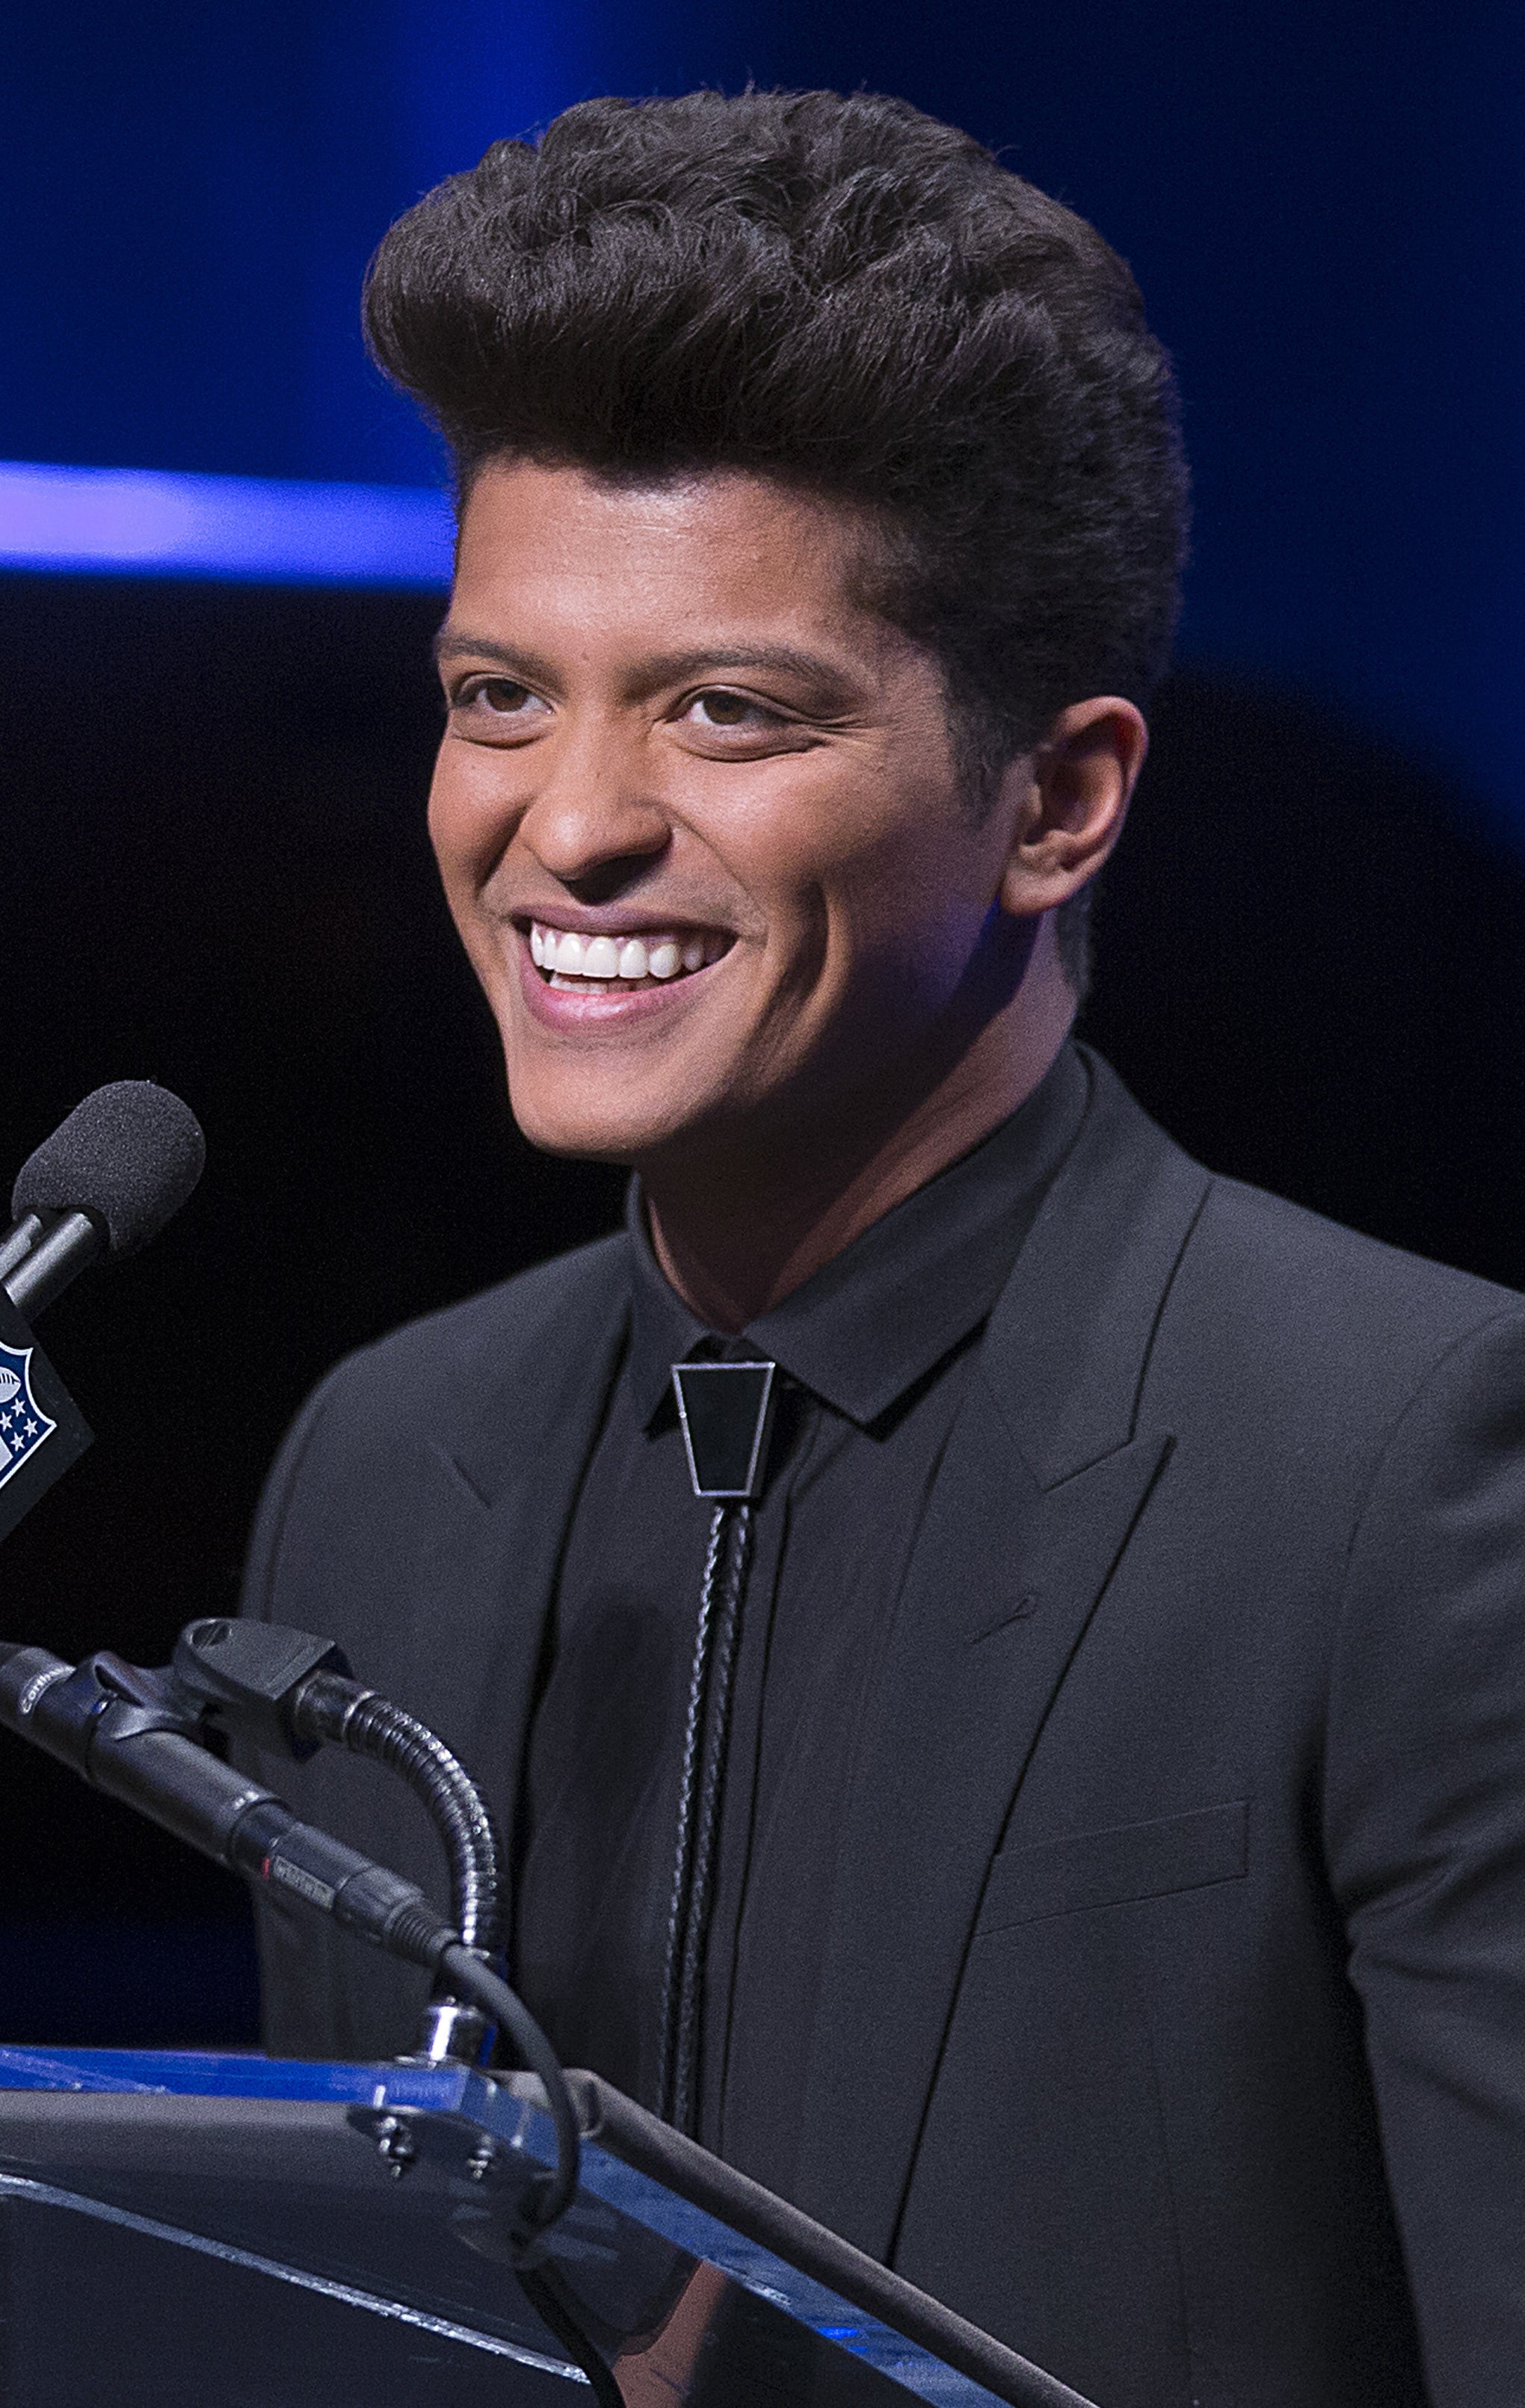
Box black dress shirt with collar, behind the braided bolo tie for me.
[513,1048,1089,2196]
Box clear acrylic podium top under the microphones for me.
[0,2047,1086,2408]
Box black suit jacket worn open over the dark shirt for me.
[248,1060,1525,2408]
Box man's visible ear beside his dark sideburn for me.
[999,694,1149,920]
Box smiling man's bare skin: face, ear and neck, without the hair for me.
[429,460,1144,1330]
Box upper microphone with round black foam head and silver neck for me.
[0,1078,207,1315]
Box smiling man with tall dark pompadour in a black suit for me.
[248,94,1525,2408]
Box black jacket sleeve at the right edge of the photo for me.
[1325,1310,1525,2408]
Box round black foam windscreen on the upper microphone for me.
[10,1078,207,1257]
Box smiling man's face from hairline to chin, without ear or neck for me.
[429,463,1031,1165]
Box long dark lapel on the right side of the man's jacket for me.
[795,1064,1207,2256]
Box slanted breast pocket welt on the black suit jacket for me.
[978,1799,1248,1931]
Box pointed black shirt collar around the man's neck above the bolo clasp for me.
[626,1045,1091,1425]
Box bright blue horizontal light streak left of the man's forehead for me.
[0,460,453,585]
